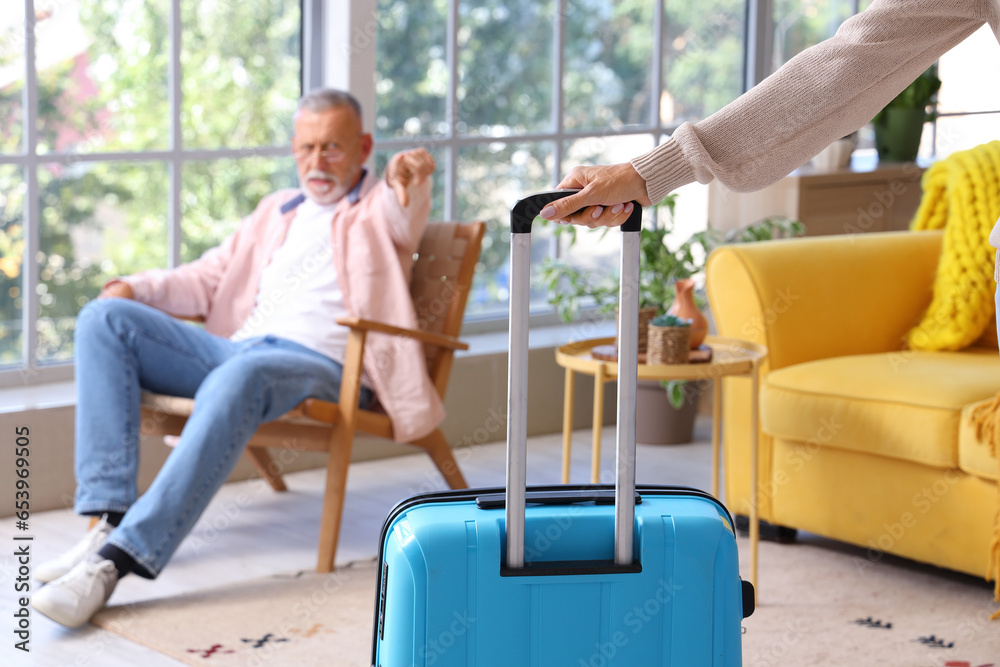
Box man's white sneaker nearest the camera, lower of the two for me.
[31,556,118,628]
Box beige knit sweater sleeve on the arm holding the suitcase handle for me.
[632,0,1000,202]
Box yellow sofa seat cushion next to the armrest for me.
[761,348,1000,468]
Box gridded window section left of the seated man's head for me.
[0,0,302,384]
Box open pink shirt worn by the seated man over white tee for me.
[126,173,444,442]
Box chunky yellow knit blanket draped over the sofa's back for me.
[906,141,1000,350]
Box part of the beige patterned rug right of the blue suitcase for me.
[740,536,1000,667]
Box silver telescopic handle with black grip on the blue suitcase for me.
[506,190,642,568]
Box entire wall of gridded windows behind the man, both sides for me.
[7,0,984,385]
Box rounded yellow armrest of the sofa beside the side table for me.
[706,231,943,369]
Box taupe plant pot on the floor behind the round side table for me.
[635,380,701,445]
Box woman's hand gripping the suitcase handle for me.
[541,162,651,227]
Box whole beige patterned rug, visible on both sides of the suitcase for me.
[94,536,1000,667]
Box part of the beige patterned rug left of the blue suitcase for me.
[93,561,375,667]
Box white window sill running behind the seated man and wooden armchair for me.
[0,321,615,414]
